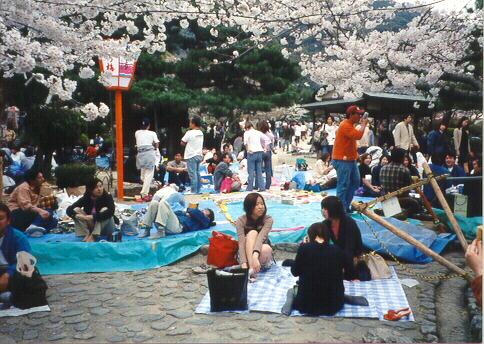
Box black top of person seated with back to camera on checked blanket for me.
[291,242,345,315]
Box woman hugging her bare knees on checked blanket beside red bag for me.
[235,192,273,278]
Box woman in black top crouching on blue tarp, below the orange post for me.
[66,178,114,242]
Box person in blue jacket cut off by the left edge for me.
[0,203,31,293]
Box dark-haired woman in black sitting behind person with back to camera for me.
[321,196,369,280]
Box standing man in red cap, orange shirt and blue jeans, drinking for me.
[332,105,368,212]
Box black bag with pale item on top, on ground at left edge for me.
[8,251,47,309]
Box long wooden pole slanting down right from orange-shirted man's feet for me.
[351,201,472,280]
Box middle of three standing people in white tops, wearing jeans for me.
[180,116,203,194]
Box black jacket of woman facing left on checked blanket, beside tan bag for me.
[323,215,363,281]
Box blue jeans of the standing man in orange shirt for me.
[332,160,360,212]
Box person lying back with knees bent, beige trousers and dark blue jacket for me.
[138,185,215,239]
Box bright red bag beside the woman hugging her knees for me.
[207,231,239,268]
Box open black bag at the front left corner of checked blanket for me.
[207,269,249,312]
